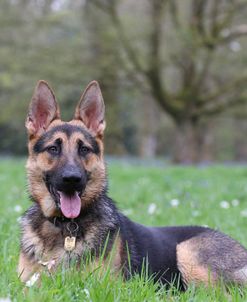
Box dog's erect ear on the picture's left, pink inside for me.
[26,81,60,135]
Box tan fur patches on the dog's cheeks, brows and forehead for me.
[26,120,106,217]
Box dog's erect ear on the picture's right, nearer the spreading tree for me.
[74,81,105,137]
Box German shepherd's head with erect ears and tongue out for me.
[26,81,106,218]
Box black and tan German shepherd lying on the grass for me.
[18,81,247,290]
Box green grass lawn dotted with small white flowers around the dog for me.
[0,159,247,302]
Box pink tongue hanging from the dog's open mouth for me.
[58,192,81,218]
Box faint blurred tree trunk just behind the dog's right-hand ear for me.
[82,1,126,154]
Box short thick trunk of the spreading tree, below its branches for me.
[173,120,213,164]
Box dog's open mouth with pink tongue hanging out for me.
[50,187,82,218]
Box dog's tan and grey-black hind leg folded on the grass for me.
[177,229,247,285]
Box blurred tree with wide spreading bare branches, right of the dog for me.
[91,0,247,162]
